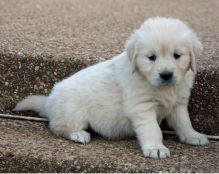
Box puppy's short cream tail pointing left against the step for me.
[13,95,47,115]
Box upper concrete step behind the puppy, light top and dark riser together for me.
[0,0,219,134]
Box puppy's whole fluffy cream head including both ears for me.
[126,17,202,86]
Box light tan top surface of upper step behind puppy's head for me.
[0,0,219,64]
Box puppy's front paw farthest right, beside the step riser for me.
[180,131,208,146]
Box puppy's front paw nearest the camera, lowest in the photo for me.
[143,145,170,159]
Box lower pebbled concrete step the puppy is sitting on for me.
[0,119,219,173]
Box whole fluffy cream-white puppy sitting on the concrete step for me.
[14,17,208,158]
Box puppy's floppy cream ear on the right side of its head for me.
[190,33,203,73]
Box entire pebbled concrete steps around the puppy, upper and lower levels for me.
[0,0,219,172]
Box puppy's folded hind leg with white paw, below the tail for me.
[49,119,91,144]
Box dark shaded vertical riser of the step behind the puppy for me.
[0,51,219,135]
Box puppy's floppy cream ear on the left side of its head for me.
[125,33,137,73]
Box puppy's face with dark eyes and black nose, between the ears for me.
[136,34,191,86]
